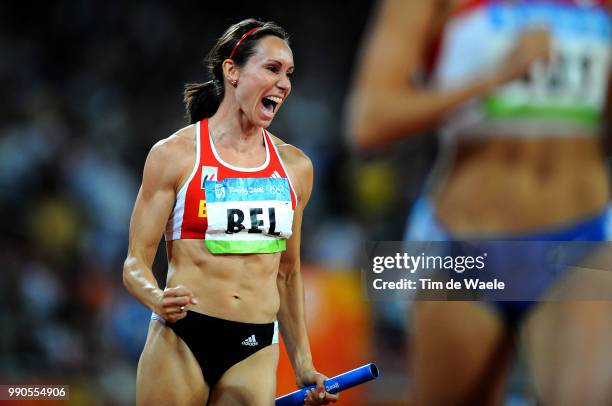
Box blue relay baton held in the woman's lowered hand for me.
[275,364,380,406]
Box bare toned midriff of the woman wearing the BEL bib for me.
[161,240,280,323]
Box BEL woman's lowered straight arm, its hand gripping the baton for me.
[277,144,338,405]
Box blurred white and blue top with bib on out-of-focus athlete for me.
[432,0,612,136]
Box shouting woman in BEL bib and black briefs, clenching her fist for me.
[123,19,337,405]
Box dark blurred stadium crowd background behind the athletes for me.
[0,0,444,405]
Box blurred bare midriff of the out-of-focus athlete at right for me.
[436,135,609,236]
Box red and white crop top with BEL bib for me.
[165,119,297,253]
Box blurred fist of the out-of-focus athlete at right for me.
[498,27,552,84]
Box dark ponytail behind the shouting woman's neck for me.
[183,80,224,124]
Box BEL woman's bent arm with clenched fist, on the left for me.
[123,138,194,321]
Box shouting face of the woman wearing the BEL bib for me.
[236,35,293,128]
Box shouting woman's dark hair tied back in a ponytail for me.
[183,18,289,124]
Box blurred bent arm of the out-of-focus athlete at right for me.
[347,0,549,148]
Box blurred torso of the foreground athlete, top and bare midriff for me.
[431,0,612,235]
